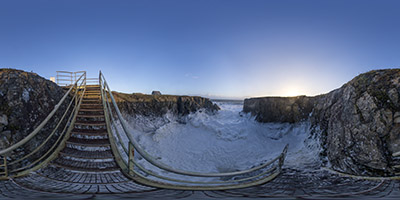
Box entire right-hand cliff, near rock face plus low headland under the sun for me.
[243,69,400,176]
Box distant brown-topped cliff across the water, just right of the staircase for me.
[113,92,219,117]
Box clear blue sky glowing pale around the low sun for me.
[0,0,400,98]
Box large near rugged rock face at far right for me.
[311,69,400,176]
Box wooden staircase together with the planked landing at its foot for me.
[11,85,154,194]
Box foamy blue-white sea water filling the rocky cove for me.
[119,101,320,180]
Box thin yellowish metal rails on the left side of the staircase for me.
[0,72,86,179]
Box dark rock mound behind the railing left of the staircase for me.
[0,69,65,153]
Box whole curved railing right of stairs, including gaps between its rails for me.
[99,71,288,190]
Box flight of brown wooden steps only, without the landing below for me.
[53,85,119,172]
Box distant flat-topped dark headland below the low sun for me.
[243,96,318,123]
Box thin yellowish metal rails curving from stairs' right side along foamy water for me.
[99,71,288,190]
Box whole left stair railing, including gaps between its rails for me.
[0,72,86,179]
